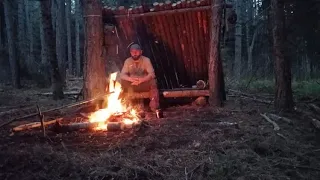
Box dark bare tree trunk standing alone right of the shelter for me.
[271,0,294,111]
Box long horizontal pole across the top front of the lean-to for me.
[114,4,232,18]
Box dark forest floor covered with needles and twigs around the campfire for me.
[0,79,320,180]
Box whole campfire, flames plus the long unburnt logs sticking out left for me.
[12,72,142,135]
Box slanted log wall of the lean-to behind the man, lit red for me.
[103,0,230,89]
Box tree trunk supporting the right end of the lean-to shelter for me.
[208,0,223,107]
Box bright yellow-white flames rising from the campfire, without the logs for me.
[89,73,139,130]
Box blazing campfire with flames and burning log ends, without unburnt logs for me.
[89,72,140,131]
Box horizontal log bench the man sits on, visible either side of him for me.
[128,90,209,99]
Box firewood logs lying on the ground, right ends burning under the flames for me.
[7,104,143,136]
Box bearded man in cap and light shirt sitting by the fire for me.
[120,44,159,111]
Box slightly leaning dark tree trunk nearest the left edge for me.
[3,0,21,88]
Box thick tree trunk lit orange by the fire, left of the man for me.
[83,0,106,99]
